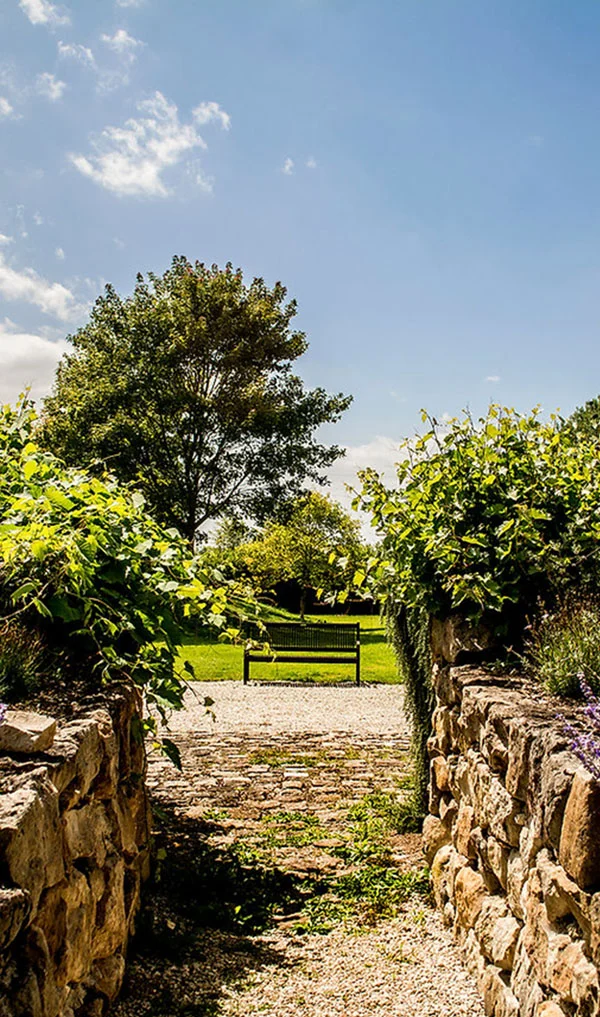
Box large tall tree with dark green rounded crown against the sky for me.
[43,257,351,541]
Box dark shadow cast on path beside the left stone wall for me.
[110,802,319,1017]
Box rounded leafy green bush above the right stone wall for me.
[359,406,600,634]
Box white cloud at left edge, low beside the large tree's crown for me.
[0,319,68,403]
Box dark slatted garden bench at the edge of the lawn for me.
[244,621,360,685]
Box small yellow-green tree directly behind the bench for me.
[236,491,366,618]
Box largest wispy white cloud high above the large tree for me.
[69,92,229,197]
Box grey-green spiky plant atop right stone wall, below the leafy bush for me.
[525,600,600,698]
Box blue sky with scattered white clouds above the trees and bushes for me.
[0,0,600,508]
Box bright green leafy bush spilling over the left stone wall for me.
[0,401,251,740]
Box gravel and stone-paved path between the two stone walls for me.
[111,681,484,1017]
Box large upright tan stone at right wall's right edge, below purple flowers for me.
[558,769,600,890]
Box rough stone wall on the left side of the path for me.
[0,693,149,1017]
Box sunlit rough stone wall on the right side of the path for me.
[424,665,600,1017]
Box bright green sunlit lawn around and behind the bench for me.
[181,611,401,684]
